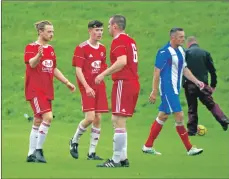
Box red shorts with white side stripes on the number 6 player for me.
[111,80,140,117]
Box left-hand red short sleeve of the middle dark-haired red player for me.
[72,46,85,68]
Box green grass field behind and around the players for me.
[2,1,229,178]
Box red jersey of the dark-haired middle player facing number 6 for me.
[72,41,107,88]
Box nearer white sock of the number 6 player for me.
[112,128,127,163]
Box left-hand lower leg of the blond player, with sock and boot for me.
[26,116,42,162]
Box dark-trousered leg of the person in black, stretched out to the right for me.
[199,86,229,131]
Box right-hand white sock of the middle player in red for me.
[89,126,100,155]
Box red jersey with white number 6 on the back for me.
[110,34,138,81]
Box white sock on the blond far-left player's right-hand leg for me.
[36,121,50,149]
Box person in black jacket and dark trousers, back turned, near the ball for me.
[183,36,229,136]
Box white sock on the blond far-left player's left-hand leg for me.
[28,125,39,156]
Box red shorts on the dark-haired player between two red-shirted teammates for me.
[80,84,108,113]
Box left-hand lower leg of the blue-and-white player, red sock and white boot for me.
[142,109,169,155]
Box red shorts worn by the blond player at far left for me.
[30,96,52,119]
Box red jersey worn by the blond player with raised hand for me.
[24,42,56,100]
